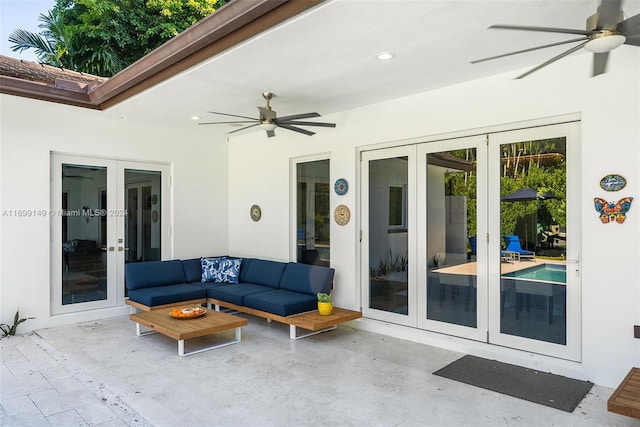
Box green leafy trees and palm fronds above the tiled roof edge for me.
[9,0,226,77]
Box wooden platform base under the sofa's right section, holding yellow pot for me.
[209,298,362,340]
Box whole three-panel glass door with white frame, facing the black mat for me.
[361,122,581,360]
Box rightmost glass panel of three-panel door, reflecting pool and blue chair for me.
[490,124,580,360]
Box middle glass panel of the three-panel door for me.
[418,137,487,339]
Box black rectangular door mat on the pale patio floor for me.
[434,356,593,412]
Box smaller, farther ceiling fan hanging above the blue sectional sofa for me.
[198,92,336,138]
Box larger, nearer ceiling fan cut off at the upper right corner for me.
[471,0,640,79]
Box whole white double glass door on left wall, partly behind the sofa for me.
[51,154,171,314]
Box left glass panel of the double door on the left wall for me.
[51,155,116,314]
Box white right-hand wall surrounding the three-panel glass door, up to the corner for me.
[229,51,640,386]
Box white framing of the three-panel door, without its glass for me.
[360,114,582,361]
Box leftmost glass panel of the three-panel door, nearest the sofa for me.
[362,147,416,325]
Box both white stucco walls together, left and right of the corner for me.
[0,46,640,386]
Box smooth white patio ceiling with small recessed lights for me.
[105,0,640,137]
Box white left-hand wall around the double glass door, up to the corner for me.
[0,95,228,332]
